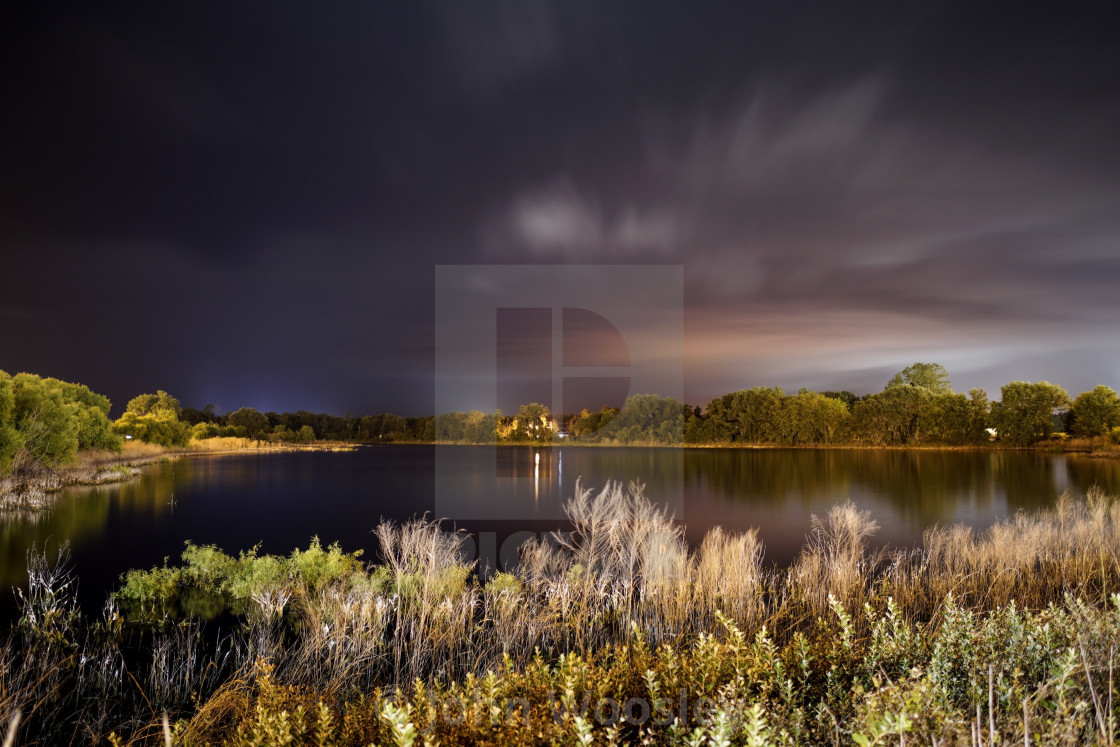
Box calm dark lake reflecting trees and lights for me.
[0,446,1120,615]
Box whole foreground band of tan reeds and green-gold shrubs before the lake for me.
[0,484,1120,746]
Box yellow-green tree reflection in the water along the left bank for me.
[0,460,185,591]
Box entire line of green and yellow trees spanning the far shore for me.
[0,363,1120,476]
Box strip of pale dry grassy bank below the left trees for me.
[0,438,357,511]
